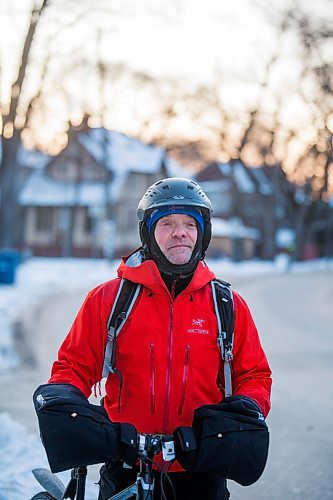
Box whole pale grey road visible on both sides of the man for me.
[0,271,333,500]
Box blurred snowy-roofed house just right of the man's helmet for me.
[195,160,275,259]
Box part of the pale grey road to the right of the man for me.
[230,272,333,500]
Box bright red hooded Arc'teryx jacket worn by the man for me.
[49,252,271,440]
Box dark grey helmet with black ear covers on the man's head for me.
[137,177,212,274]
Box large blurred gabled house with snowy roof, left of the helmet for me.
[19,123,189,257]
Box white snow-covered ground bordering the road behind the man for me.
[0,258,333,500]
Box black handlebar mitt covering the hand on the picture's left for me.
[33,384,137,472]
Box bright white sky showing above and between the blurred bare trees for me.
[0,0,328,158]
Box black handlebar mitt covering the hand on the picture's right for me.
[176,396,269,486]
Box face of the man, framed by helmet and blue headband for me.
[155,214,198,264]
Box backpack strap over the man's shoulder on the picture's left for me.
[102,278,141,377]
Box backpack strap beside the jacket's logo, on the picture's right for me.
[211,279,234,397]
